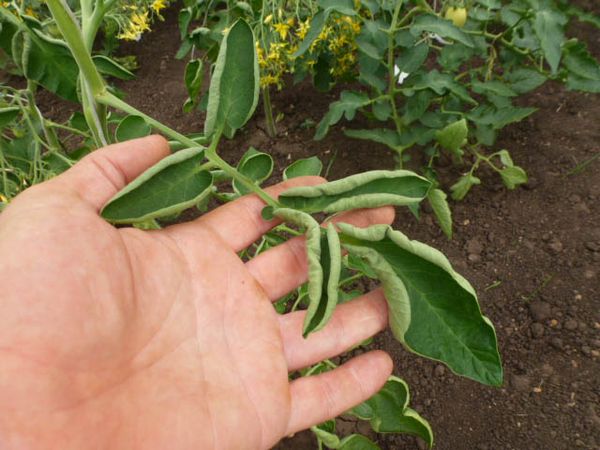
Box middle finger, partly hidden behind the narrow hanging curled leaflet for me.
[246,206,394,301]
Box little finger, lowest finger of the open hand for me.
[286,351,392,435]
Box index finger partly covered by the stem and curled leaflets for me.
[169,177,325,252]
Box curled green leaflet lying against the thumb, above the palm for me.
[101,148,212,223]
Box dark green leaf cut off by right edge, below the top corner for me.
[563,40,600,93]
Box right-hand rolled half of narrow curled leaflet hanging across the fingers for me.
[302,223,342,337]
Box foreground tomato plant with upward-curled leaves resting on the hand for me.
[0,0,511,450]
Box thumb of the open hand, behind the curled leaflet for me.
[50,135,170,211]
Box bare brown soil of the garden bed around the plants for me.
[24,1,600,450]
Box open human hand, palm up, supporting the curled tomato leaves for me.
[0,136,393,449]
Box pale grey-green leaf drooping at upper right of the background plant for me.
[533,9,566,74]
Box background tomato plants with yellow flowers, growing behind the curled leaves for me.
[175,0,600,218]
